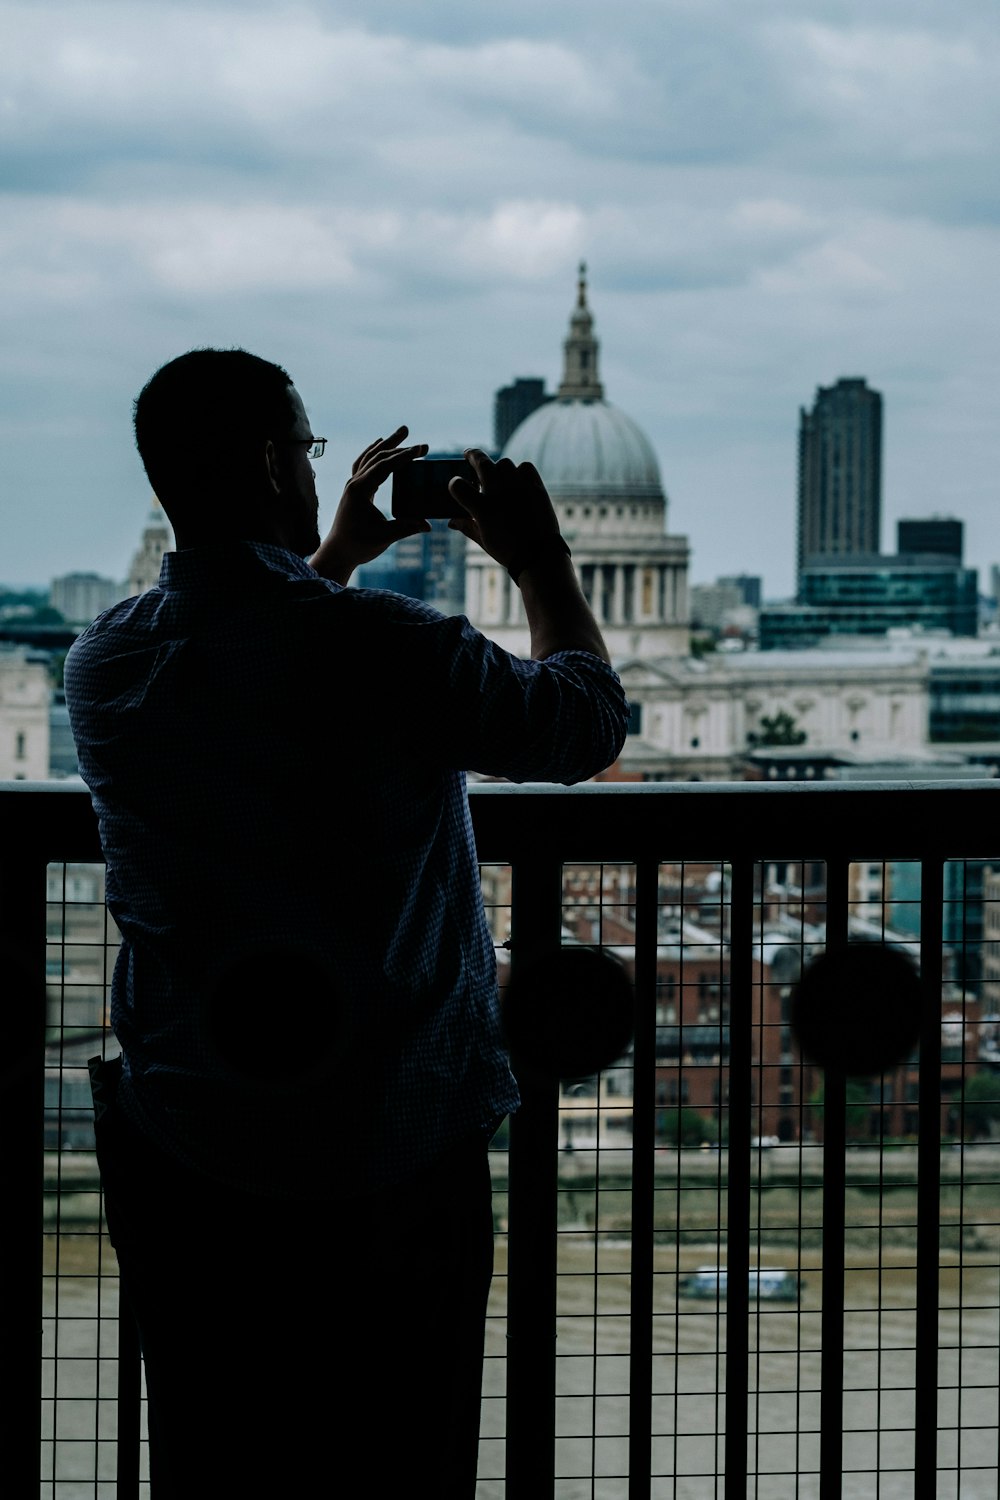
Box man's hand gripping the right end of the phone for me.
[448,449,559,567]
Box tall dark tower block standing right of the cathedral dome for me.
[798,378,882,579]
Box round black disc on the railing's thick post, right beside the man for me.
[501,947,634,1079]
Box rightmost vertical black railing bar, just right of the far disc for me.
[913,860,945,1500]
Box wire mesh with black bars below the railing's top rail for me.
[15,786,1000,1500]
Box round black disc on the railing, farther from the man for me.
[792,942,924,1077]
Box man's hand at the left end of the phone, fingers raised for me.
[309,428,430,584]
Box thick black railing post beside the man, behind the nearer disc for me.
[505,854,562,1500]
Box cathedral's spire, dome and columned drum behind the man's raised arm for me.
[465,267,690,659]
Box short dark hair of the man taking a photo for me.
[133,350,294,515]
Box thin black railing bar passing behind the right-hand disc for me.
[820,860,849,1500]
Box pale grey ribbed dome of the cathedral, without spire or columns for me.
[504,398,663,500]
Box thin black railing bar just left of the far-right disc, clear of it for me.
[724,857,754,1500]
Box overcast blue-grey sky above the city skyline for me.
[0,0,1000,597]
